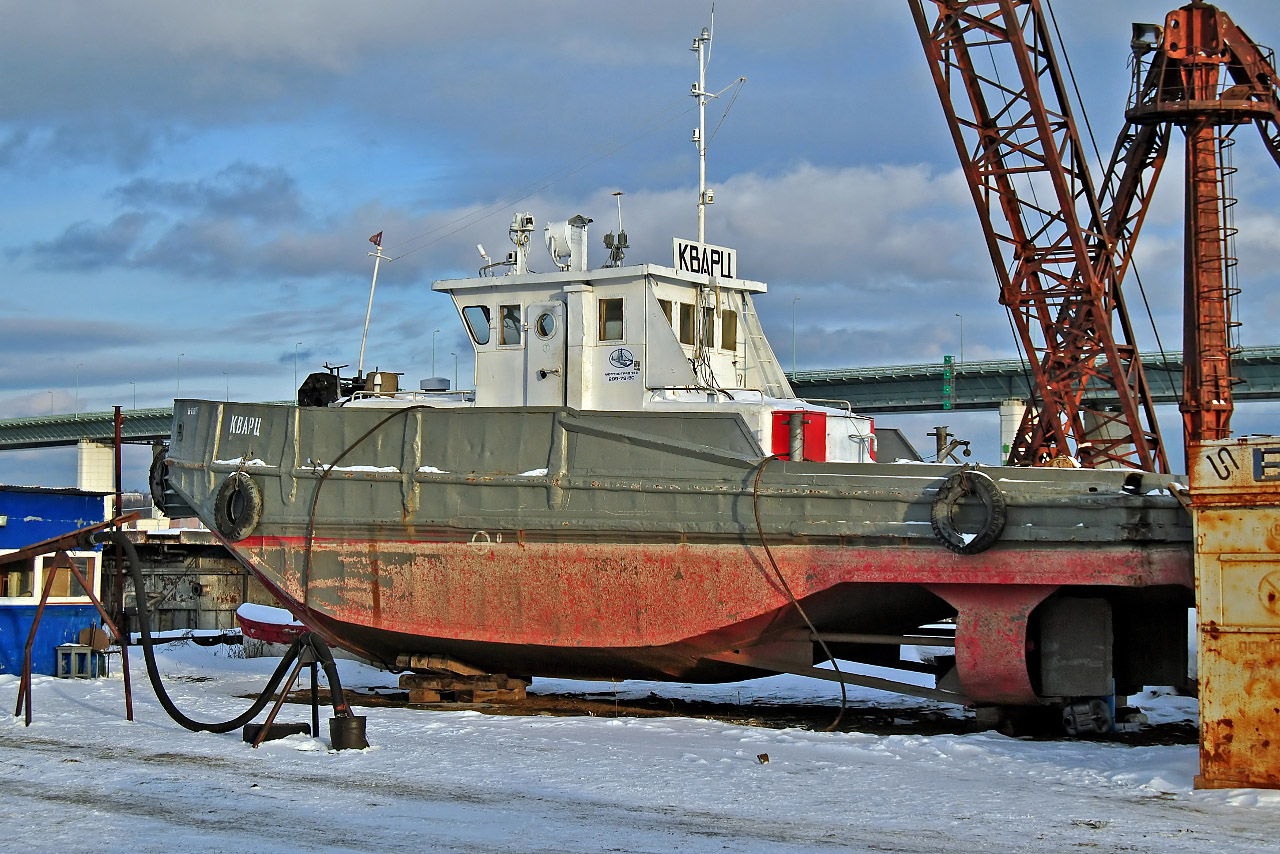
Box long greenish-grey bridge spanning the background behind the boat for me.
[0,347,1280,451]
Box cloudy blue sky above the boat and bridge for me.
[0,0,1280,487]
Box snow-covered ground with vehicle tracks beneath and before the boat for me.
[0,644,1280,854]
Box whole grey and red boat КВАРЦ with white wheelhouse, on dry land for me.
[152,25,1194,727]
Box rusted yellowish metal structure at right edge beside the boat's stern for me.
[1189,437,1280,787]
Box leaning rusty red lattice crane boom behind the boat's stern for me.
[911,0,1169,471]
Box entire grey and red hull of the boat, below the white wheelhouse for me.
[166,401,1192,704]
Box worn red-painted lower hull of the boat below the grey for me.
[217,536,1193,704]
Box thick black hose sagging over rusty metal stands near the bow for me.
[93,531,351,732]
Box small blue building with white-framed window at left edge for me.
[0,485,106,676]
